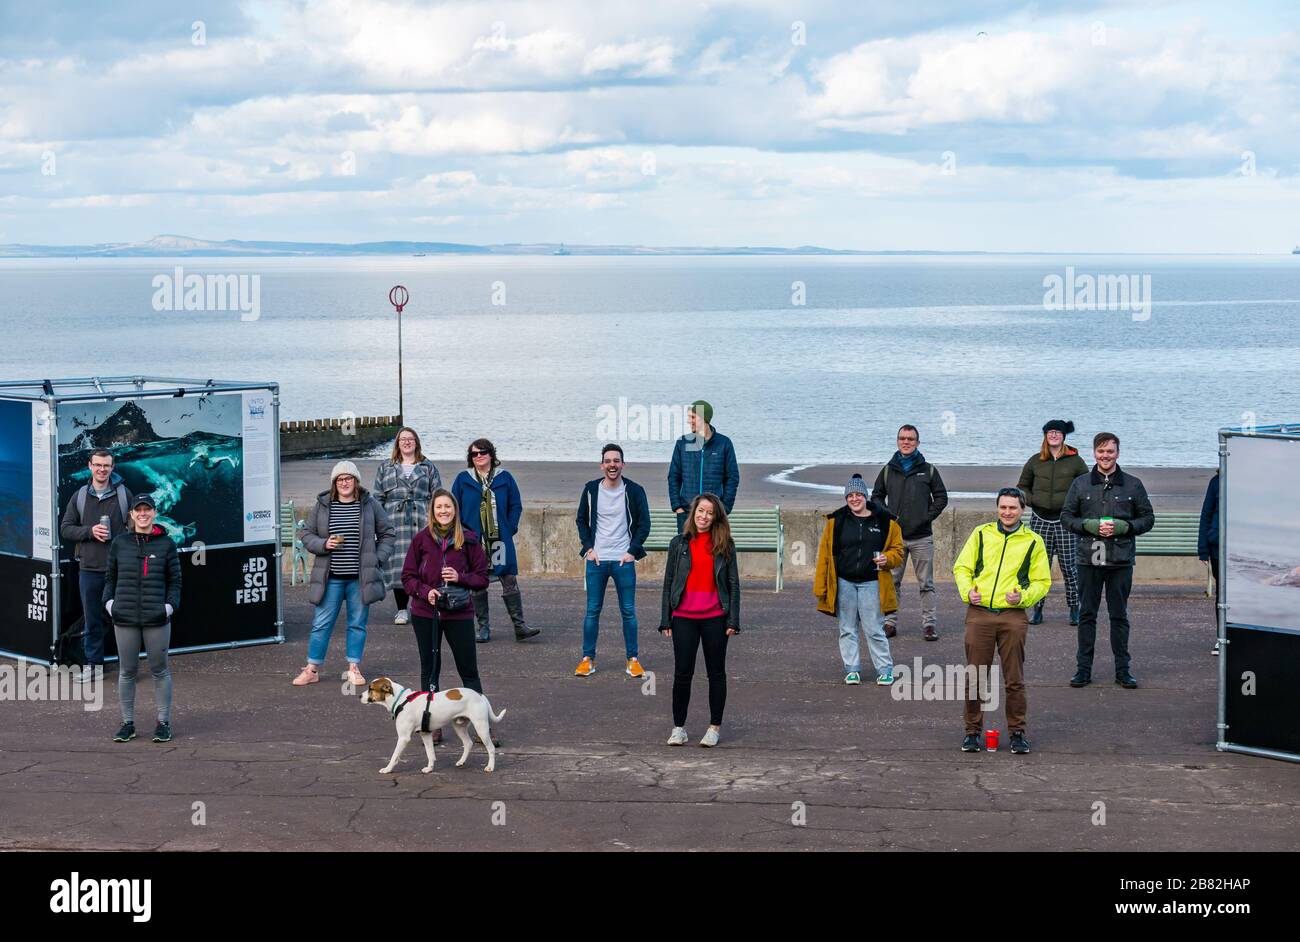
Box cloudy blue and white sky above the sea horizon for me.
[0,0,1300,252]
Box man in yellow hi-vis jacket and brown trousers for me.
[953,487,1052,754]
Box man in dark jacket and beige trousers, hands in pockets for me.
[871,425,948,641]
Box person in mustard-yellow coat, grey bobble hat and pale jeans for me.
[813,474,904,687]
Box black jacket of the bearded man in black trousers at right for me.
[1061,465,1156,566]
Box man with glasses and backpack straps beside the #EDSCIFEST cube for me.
[59,448,131,678]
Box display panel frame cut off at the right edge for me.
[1216,422,1300,761]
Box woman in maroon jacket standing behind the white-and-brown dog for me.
[402,487,488,741]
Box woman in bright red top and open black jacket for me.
[659,494,740,746]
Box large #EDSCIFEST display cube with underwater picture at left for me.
[0,376,285,664]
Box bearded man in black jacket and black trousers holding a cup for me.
[1061,431,1156,690]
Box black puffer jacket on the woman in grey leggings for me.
[104,524,181,628]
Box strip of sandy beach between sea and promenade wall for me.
[280,457,1217,512]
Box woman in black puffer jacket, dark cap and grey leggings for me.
[104,494,181,742]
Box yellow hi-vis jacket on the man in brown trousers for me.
[953,521,1052,608]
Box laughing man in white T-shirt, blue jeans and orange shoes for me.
[573,443,650,678]
